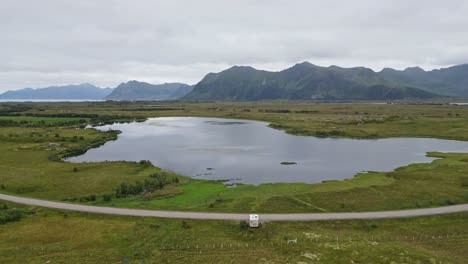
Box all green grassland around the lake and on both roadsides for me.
[0,102,468,263]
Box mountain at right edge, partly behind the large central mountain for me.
[378,64,468,97]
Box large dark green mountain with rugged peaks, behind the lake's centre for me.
[183,62,438,101]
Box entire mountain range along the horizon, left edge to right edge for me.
[0,62,468,101]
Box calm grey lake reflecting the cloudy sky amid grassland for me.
[67,117,468,184]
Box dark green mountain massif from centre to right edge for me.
[182,62,468,101]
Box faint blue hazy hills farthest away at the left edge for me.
[0,83,112,100]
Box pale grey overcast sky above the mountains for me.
[0,0,468,91]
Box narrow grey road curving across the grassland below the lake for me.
[0,194,468,221]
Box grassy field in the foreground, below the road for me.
[0,204,468,263]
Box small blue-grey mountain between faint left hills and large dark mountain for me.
[106,81,192,101]
